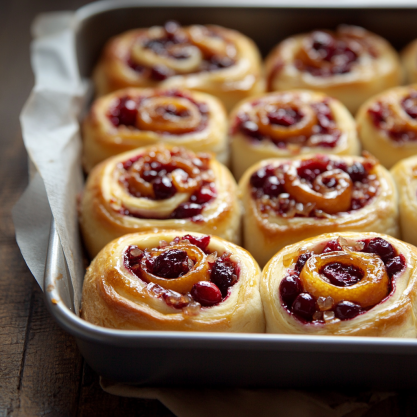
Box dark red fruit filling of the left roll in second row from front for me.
[118,148,217,221]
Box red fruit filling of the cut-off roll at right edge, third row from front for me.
[368,90,417,143]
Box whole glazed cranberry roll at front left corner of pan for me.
[82,230,265,333]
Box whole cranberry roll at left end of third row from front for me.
[83,88,229,172]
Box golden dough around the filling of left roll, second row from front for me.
[80,145,241,256]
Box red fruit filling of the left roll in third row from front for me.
[107,89,209,135]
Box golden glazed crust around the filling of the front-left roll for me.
[82,230,265,333]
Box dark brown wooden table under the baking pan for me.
[0,0,417,417]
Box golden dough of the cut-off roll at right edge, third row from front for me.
[356,84,417,169]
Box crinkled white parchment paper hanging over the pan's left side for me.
[13,12,88,314]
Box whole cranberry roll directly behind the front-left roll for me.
[80,145,240,256]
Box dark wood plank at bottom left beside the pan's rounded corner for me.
[19,283,83,417]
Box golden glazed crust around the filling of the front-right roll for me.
[261,232,417,338]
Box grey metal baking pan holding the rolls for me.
[44,0,417,389]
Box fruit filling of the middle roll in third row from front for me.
[232,93,341,148]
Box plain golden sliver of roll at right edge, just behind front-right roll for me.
[391,155,417,246]
